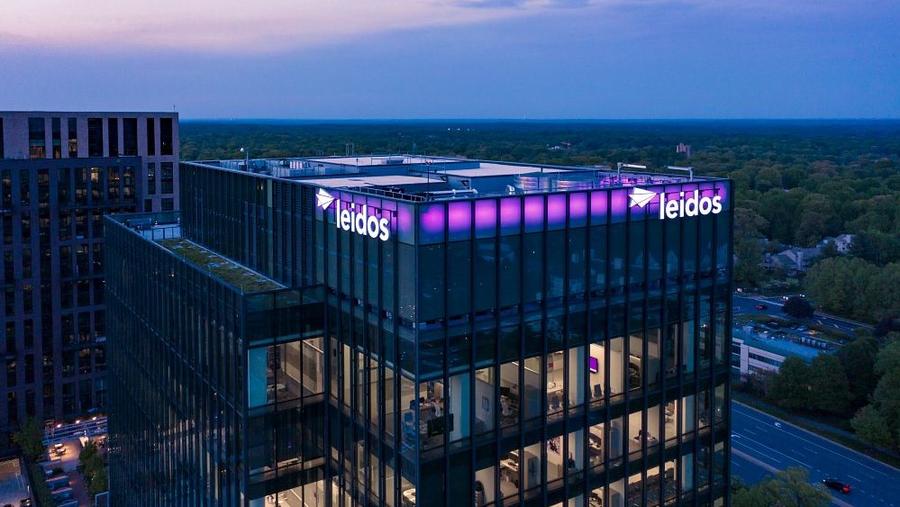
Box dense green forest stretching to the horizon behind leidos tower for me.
[180,120,900,322]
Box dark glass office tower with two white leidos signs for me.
[106,156,733,507]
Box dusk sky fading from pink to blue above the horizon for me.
[0,0,900,119]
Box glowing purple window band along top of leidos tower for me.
[320,181,731,243]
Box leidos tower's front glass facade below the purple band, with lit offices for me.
[319,188,729,507]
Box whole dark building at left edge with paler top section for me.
[0,111,178,447]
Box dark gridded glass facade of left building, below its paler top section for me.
[0,157,141,447]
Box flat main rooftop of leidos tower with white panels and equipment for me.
[191,155,720,201]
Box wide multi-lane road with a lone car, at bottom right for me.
[731,403,900,507]
